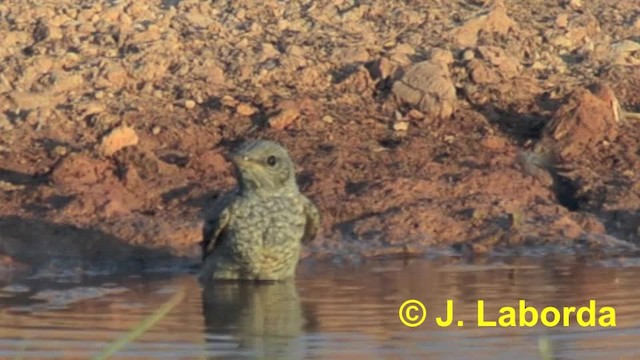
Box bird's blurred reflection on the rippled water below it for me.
[202,280,315,359]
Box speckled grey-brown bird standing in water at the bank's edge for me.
[199,140,320,282]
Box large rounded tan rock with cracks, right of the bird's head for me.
[392,55,456,118]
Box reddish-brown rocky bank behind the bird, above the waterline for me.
[0,0,640,272]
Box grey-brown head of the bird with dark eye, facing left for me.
[230,140,298,195]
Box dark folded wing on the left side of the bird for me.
[200,190,237,260]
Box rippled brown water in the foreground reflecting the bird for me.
[0,257,640,360]
